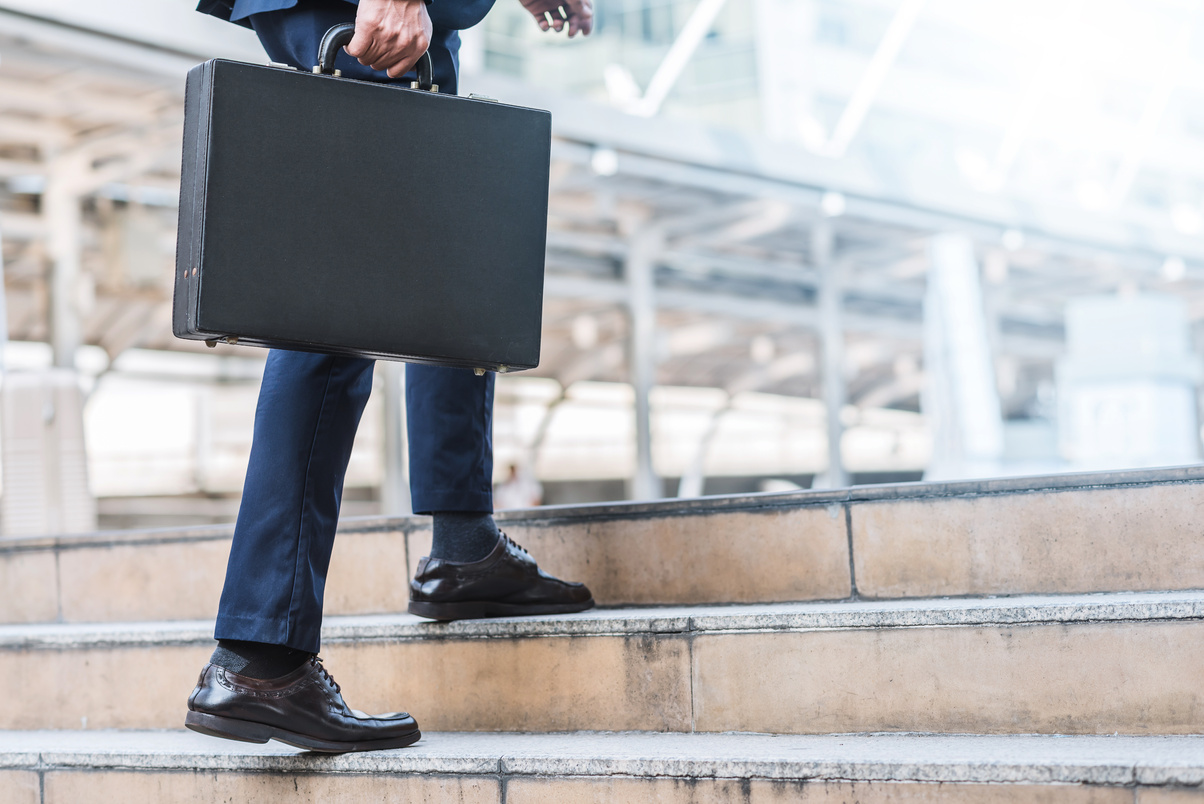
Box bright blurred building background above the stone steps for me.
[0,0,1204,533]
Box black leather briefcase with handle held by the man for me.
[172,25,551,371]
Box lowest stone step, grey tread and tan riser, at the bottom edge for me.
[0,731,1204,804]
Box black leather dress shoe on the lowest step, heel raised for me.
[184,656,423,753]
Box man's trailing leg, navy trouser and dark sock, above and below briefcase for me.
[203,0,418,675]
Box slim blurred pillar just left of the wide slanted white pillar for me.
[811,218,849,489]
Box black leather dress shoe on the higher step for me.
[409,533,594,620]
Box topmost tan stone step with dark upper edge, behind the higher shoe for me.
[7,467,1204,622]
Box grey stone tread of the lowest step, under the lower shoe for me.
[0,731,1204,785]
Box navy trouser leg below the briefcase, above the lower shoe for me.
[216,349,372,654]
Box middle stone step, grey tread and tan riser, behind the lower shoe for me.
[0,592,1204,734]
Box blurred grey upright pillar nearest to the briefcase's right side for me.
[624,229,663,499]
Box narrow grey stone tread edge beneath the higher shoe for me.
[9,591,1204,649]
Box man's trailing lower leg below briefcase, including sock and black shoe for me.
[184,350,421,752]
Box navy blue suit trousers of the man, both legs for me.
[214,2,494,654]
